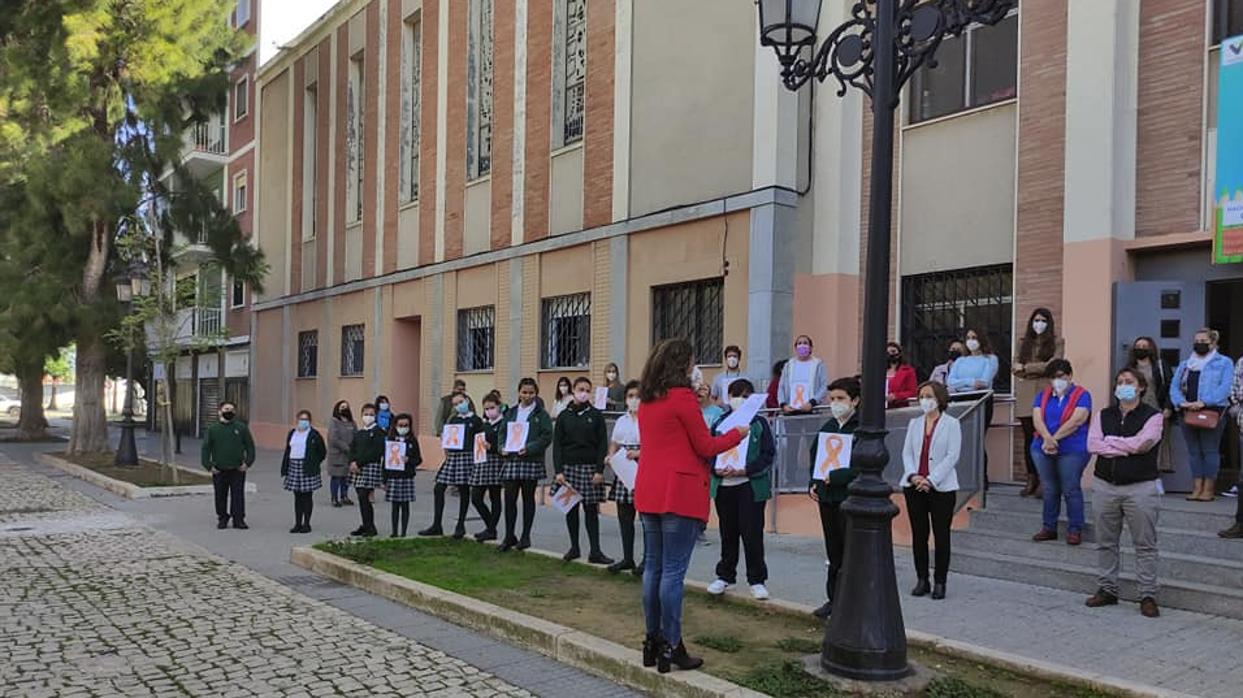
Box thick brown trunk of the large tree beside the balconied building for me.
[68,221,112,455]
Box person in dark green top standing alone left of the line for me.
[203,401,255,529]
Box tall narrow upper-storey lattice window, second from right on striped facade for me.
[466,0,492,180]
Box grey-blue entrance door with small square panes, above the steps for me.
[1108,281,1204,492]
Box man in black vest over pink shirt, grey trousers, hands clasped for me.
[1088,369,1165,619]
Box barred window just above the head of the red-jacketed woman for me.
[651,278,725,363]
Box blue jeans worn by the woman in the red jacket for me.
[640,514,704,647]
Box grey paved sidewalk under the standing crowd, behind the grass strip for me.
[45,424,1243,698]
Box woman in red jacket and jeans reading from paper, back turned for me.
[634,339,750,673]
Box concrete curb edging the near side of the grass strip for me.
[290,546,764,698]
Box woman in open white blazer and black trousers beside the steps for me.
[902,381,962,599]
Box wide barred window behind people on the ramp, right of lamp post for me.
[902,265,1014,392]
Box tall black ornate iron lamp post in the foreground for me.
[757,0,1017,681]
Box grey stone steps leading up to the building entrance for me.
[950,486,1243,620]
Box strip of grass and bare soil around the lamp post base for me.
[316,538,1128,698]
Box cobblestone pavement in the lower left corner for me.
[0,455,531,698]
